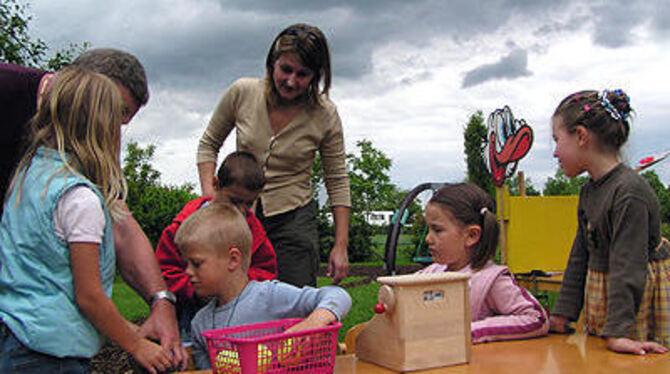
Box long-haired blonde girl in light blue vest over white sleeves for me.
[0,67,170,373]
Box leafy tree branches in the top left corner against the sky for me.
[0,0,88,71]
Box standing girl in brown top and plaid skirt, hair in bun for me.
[550,90,670,354]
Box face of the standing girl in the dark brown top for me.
[551,117,585,178]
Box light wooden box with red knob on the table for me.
[356,272,471,372]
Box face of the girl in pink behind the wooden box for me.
[426,203,471,271]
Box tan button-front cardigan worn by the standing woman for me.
[197,78,351,217]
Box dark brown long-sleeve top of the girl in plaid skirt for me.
[553,164,667,337]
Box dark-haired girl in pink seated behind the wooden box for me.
[418,183,549,344]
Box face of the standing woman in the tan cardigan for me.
[272,53,314,101]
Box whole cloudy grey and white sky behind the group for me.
[28,0,670,189]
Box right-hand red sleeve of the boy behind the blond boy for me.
[247,210,277,281]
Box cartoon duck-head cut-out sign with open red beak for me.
[484,105,533,187]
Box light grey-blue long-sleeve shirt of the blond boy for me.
[191,280,351,369]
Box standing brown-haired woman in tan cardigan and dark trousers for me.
[197,24,351,286]
